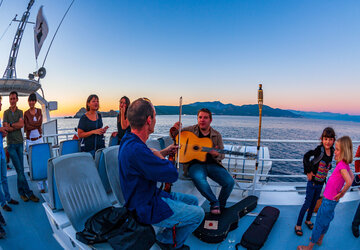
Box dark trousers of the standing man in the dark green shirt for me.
[8,143,33,197]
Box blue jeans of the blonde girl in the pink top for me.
[311,197,338,243]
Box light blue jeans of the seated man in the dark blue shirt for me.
[154,193,205,248]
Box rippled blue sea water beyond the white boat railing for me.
[58,115,360,181]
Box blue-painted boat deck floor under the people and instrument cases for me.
[0,173,360,250]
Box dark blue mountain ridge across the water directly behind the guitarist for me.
[155,101,302,118]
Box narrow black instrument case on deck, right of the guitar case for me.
[240,206,280,250]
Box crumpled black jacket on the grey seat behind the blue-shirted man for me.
[76,207,155,250]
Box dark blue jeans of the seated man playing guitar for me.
[188,163,235,207]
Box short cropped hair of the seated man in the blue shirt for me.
[127,98,154,130]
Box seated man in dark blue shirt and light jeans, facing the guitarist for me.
[119,98,204,249]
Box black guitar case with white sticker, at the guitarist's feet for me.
[194,196,258,243]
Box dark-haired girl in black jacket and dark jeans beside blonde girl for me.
[295,127,335,236]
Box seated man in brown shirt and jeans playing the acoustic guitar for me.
[170,108,235,214]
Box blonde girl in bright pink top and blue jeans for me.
[297,136,354,250]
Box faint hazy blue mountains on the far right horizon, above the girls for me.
[288,110,360,122]
